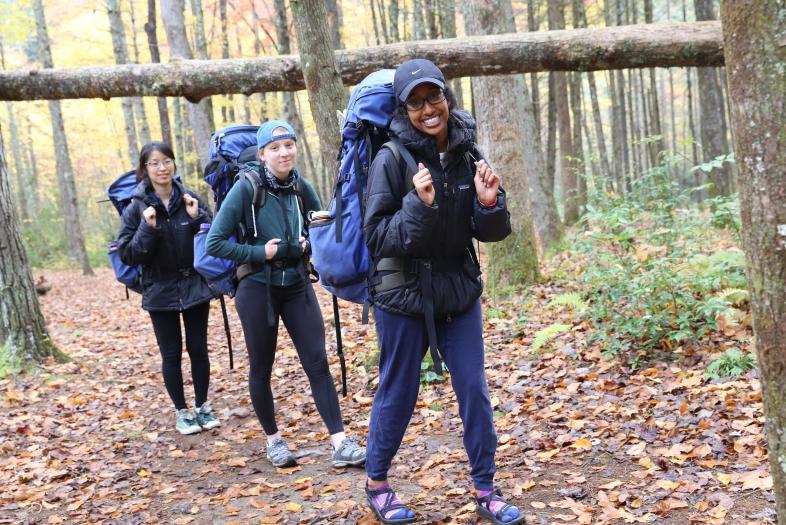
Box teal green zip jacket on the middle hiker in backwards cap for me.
[206,168,322,286]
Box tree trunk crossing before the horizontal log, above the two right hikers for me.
[289,0,348,198]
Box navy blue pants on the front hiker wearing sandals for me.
[366,301,497,490]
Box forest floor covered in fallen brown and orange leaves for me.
[0,269,775,525]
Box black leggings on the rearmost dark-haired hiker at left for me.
[149,302,210,410]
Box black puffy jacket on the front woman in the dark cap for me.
[363,110,511,319]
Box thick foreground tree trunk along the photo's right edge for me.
[721,0,786,523]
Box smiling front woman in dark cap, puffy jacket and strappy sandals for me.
[363,59,524,525]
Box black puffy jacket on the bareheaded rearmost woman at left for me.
[117,180,213,312]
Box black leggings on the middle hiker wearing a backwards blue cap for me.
[235,278,344,435]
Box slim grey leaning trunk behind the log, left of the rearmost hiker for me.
[33,0,93,275]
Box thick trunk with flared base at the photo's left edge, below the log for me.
[0,125,65,368]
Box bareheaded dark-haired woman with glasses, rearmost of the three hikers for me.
[117,142,220,434]
